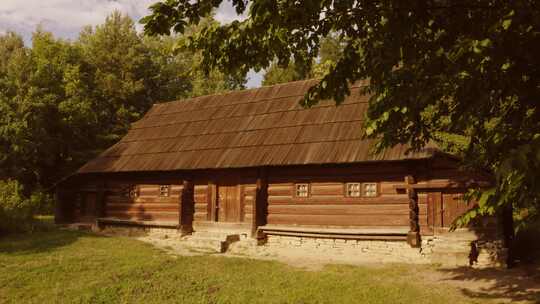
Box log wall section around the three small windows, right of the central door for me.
[267,164,432,234]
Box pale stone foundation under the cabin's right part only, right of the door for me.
[253,230,506,267]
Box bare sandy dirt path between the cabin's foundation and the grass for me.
[138,236,540,303]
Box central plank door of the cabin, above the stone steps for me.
[216,183,241,222]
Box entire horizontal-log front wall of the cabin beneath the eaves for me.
[64,159,486,235]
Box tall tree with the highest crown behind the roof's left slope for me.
[78,11,156,144]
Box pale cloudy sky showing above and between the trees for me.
[0,0,262,87]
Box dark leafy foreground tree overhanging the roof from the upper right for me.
[142,0,540,226]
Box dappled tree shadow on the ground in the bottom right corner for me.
[440,264,540,303]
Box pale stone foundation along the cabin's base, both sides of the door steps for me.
[95,225,506,267]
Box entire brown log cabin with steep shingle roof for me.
[56,80,504,264]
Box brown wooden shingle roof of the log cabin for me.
[78,80,433,173]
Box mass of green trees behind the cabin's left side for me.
[0,12,245,195]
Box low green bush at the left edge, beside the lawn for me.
[0,179,36,234]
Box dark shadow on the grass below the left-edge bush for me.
[0,228,105,255]
